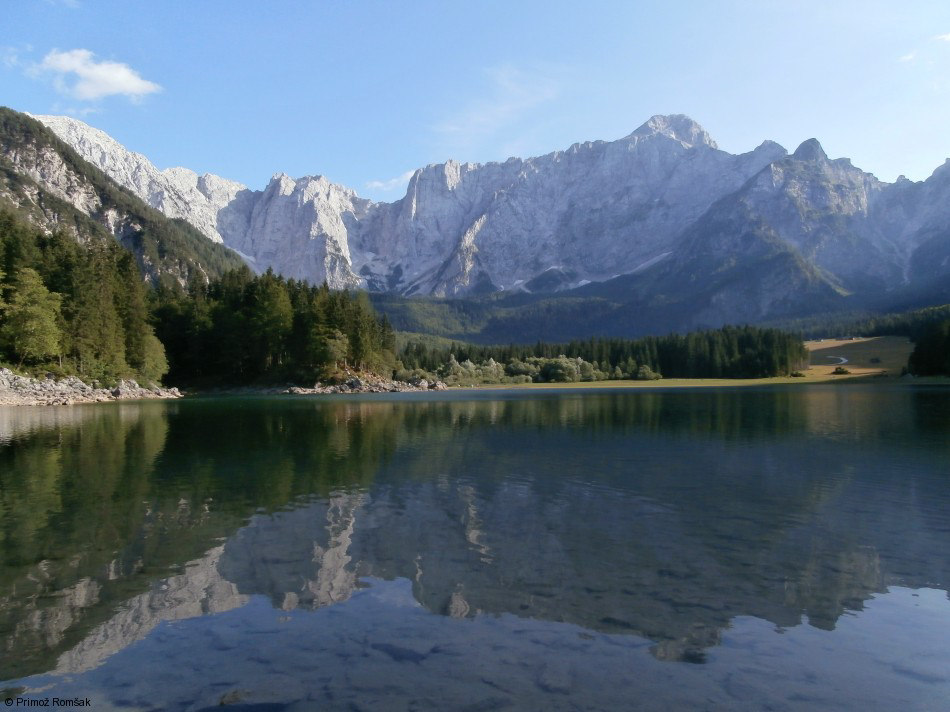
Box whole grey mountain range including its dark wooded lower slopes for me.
[5,105,950,340]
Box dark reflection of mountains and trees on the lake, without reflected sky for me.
[0,386,950,700]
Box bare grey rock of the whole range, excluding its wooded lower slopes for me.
[38,115,950,306]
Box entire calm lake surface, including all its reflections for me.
[0,386,950,711]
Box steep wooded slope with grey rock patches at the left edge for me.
[0,108,242,285]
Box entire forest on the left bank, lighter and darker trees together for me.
[0,209,396,386]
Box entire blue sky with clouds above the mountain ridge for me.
[0,0,950,200]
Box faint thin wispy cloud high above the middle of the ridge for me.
[434,65,559,137]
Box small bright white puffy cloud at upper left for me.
[33,49,162,101]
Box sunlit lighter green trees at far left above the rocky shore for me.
[0,209,168,383]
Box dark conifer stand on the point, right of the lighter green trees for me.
[154,267,395,385]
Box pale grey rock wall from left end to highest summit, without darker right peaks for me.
[37,116,785,295]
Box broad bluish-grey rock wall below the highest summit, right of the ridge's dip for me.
[355,116,784,296]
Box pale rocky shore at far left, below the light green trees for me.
[0,368,182,405]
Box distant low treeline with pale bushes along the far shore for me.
[397,326,808,383]
